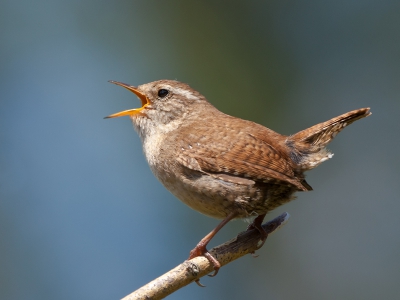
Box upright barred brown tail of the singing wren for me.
[286,108,371,171]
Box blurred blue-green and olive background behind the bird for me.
[0,0,400,300]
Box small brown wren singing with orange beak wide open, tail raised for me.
[106,80,371,276]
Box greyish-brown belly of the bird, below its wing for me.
[150,168,294,219]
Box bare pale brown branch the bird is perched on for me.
[122,213,289,300]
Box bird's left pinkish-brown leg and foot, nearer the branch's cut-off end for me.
[189,212,237,285]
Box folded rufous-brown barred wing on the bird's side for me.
[177,122,310,190]
